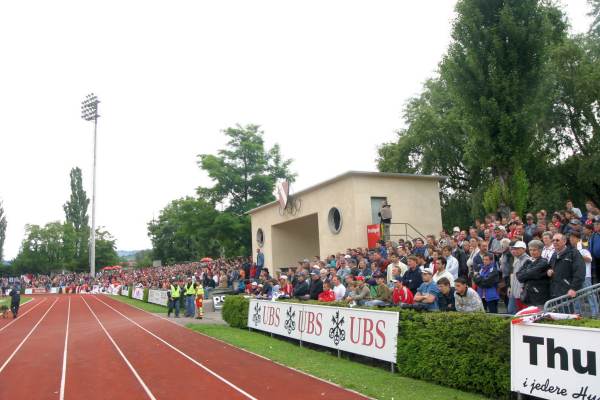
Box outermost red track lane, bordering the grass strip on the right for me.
[94,296,366,400]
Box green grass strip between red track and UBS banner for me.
[187,324,484,400]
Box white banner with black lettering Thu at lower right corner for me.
[511,324,600,400]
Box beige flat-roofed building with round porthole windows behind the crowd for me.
[248,171,444,273]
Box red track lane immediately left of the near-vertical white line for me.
[0,296,68,400]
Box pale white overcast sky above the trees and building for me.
[0,0,589,259]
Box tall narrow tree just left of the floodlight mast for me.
[63,167,90,261]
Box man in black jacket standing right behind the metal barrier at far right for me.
[548,233,585,298]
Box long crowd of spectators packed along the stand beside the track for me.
[1,201,600,314]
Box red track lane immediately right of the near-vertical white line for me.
[65,295,148,400]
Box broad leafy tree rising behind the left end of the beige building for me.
[198,125,295,215]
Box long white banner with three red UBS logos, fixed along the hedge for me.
[248,299,399,363]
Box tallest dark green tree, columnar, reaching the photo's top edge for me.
[440,0,566,211]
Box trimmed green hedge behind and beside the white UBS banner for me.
[222,296,510,399]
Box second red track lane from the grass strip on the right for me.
[84,296,248,400]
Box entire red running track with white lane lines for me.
[0,295,365,400]
